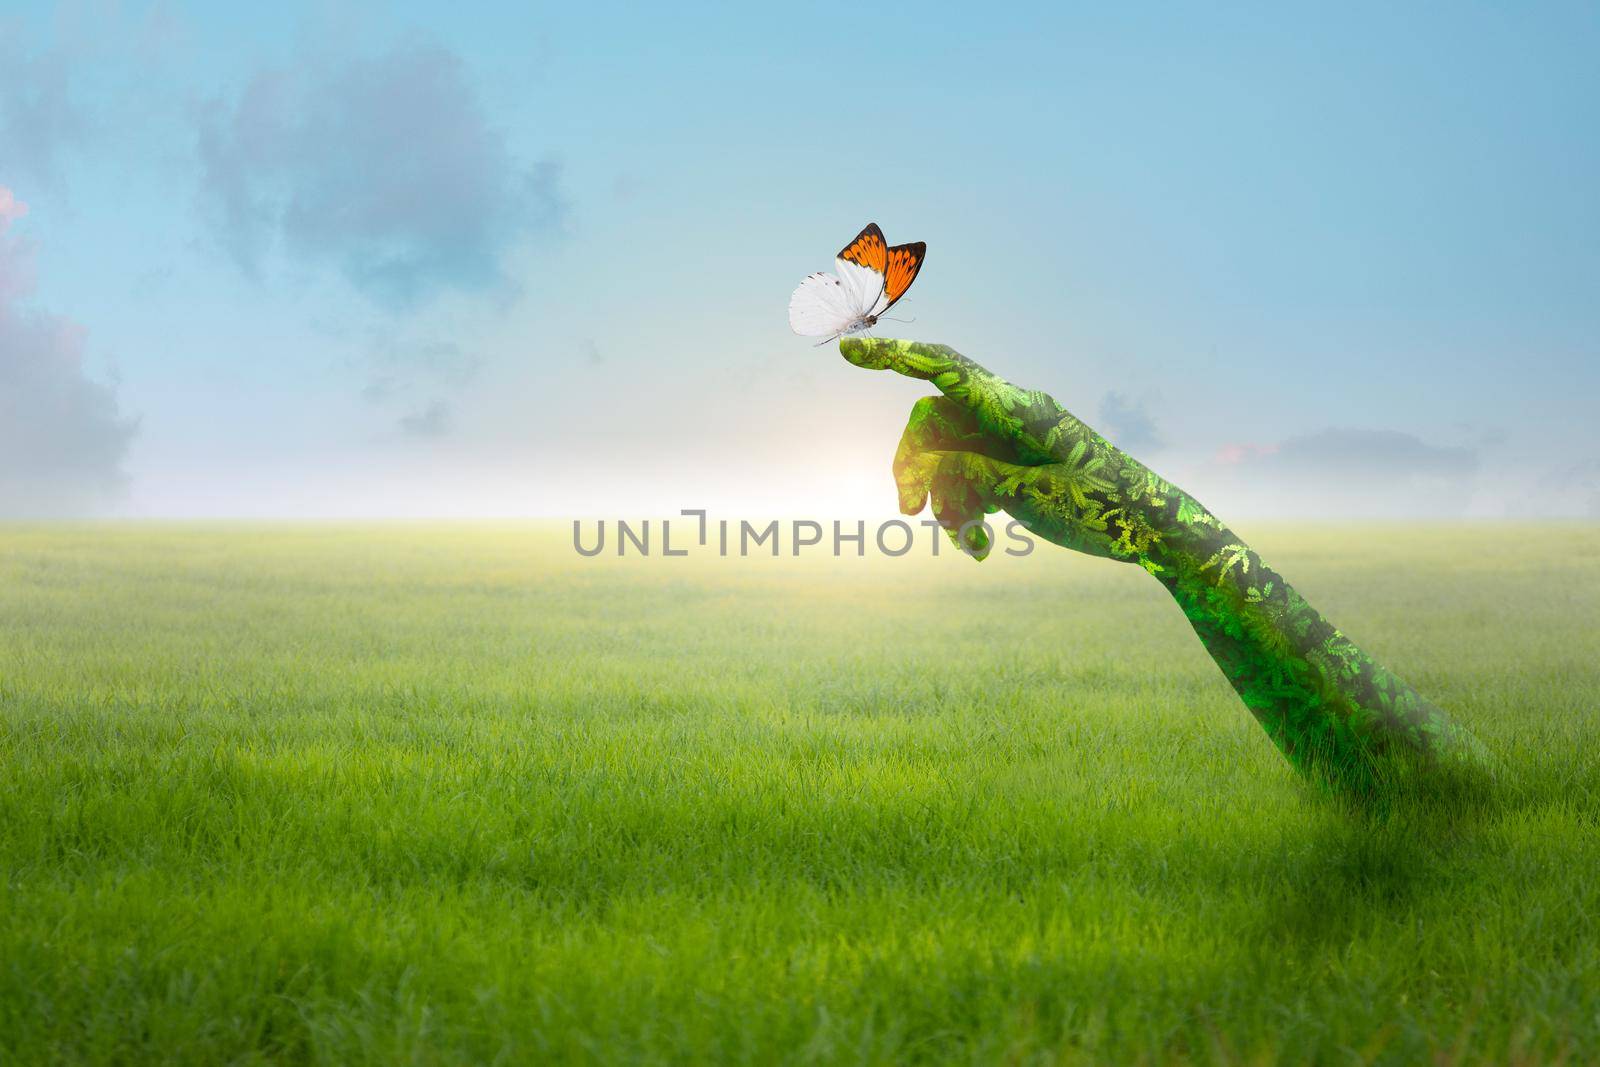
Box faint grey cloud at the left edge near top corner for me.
[0,42,85,187]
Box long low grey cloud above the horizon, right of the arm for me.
[1195,429,1480,518]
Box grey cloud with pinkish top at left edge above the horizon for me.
[0,187,138,515]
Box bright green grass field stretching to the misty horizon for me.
[0,525,1600,1064]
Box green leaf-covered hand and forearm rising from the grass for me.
[840,338,1490,792]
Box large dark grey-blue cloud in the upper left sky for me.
[198,45,565,309]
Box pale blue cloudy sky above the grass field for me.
[0,2,1600,518]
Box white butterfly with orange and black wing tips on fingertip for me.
[789,222,928,344]
